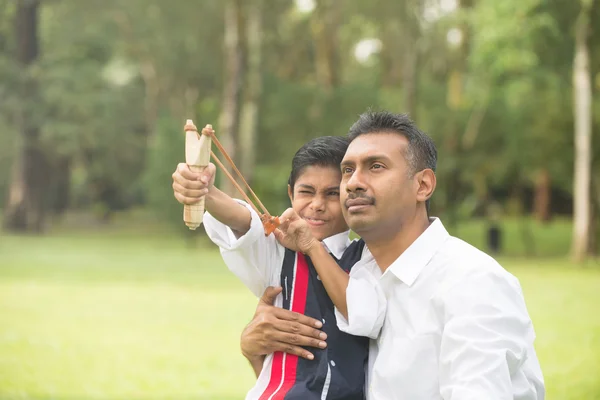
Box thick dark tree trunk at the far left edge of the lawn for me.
[4,1,49,232]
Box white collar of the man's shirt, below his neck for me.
[385,217,450,286]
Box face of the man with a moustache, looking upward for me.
[340,132,419,240]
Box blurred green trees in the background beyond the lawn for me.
[0,0,600,259]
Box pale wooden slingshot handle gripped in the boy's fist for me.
[183,119,212,230]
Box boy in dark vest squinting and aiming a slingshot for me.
[173,136,368,400]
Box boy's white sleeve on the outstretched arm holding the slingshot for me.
[203,199,285,297]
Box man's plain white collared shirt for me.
[336,218,545,400]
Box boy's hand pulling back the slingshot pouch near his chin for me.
[273,208,320,254]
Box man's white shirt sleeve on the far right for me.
[439,268,544,400]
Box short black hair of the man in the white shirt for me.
[348,111,437,177]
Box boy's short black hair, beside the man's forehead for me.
[288,136,349,193]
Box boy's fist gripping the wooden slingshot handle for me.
[172,163,216,204]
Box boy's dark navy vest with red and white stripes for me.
[260,240,369,400]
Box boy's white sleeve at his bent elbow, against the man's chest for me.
[335,264,387,339]
